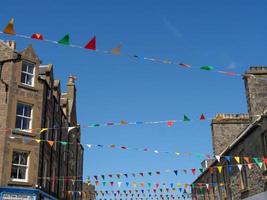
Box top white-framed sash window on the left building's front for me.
[21,61,34,86]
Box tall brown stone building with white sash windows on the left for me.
[0,41,83,199]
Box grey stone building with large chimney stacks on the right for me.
[192,67,267,200]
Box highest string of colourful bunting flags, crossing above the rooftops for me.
[0,19,241,76]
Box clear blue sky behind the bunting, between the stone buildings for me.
[0,0,267,197]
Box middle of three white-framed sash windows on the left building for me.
[16,103,32,130]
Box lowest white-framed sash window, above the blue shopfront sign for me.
[11,151,29,182]
